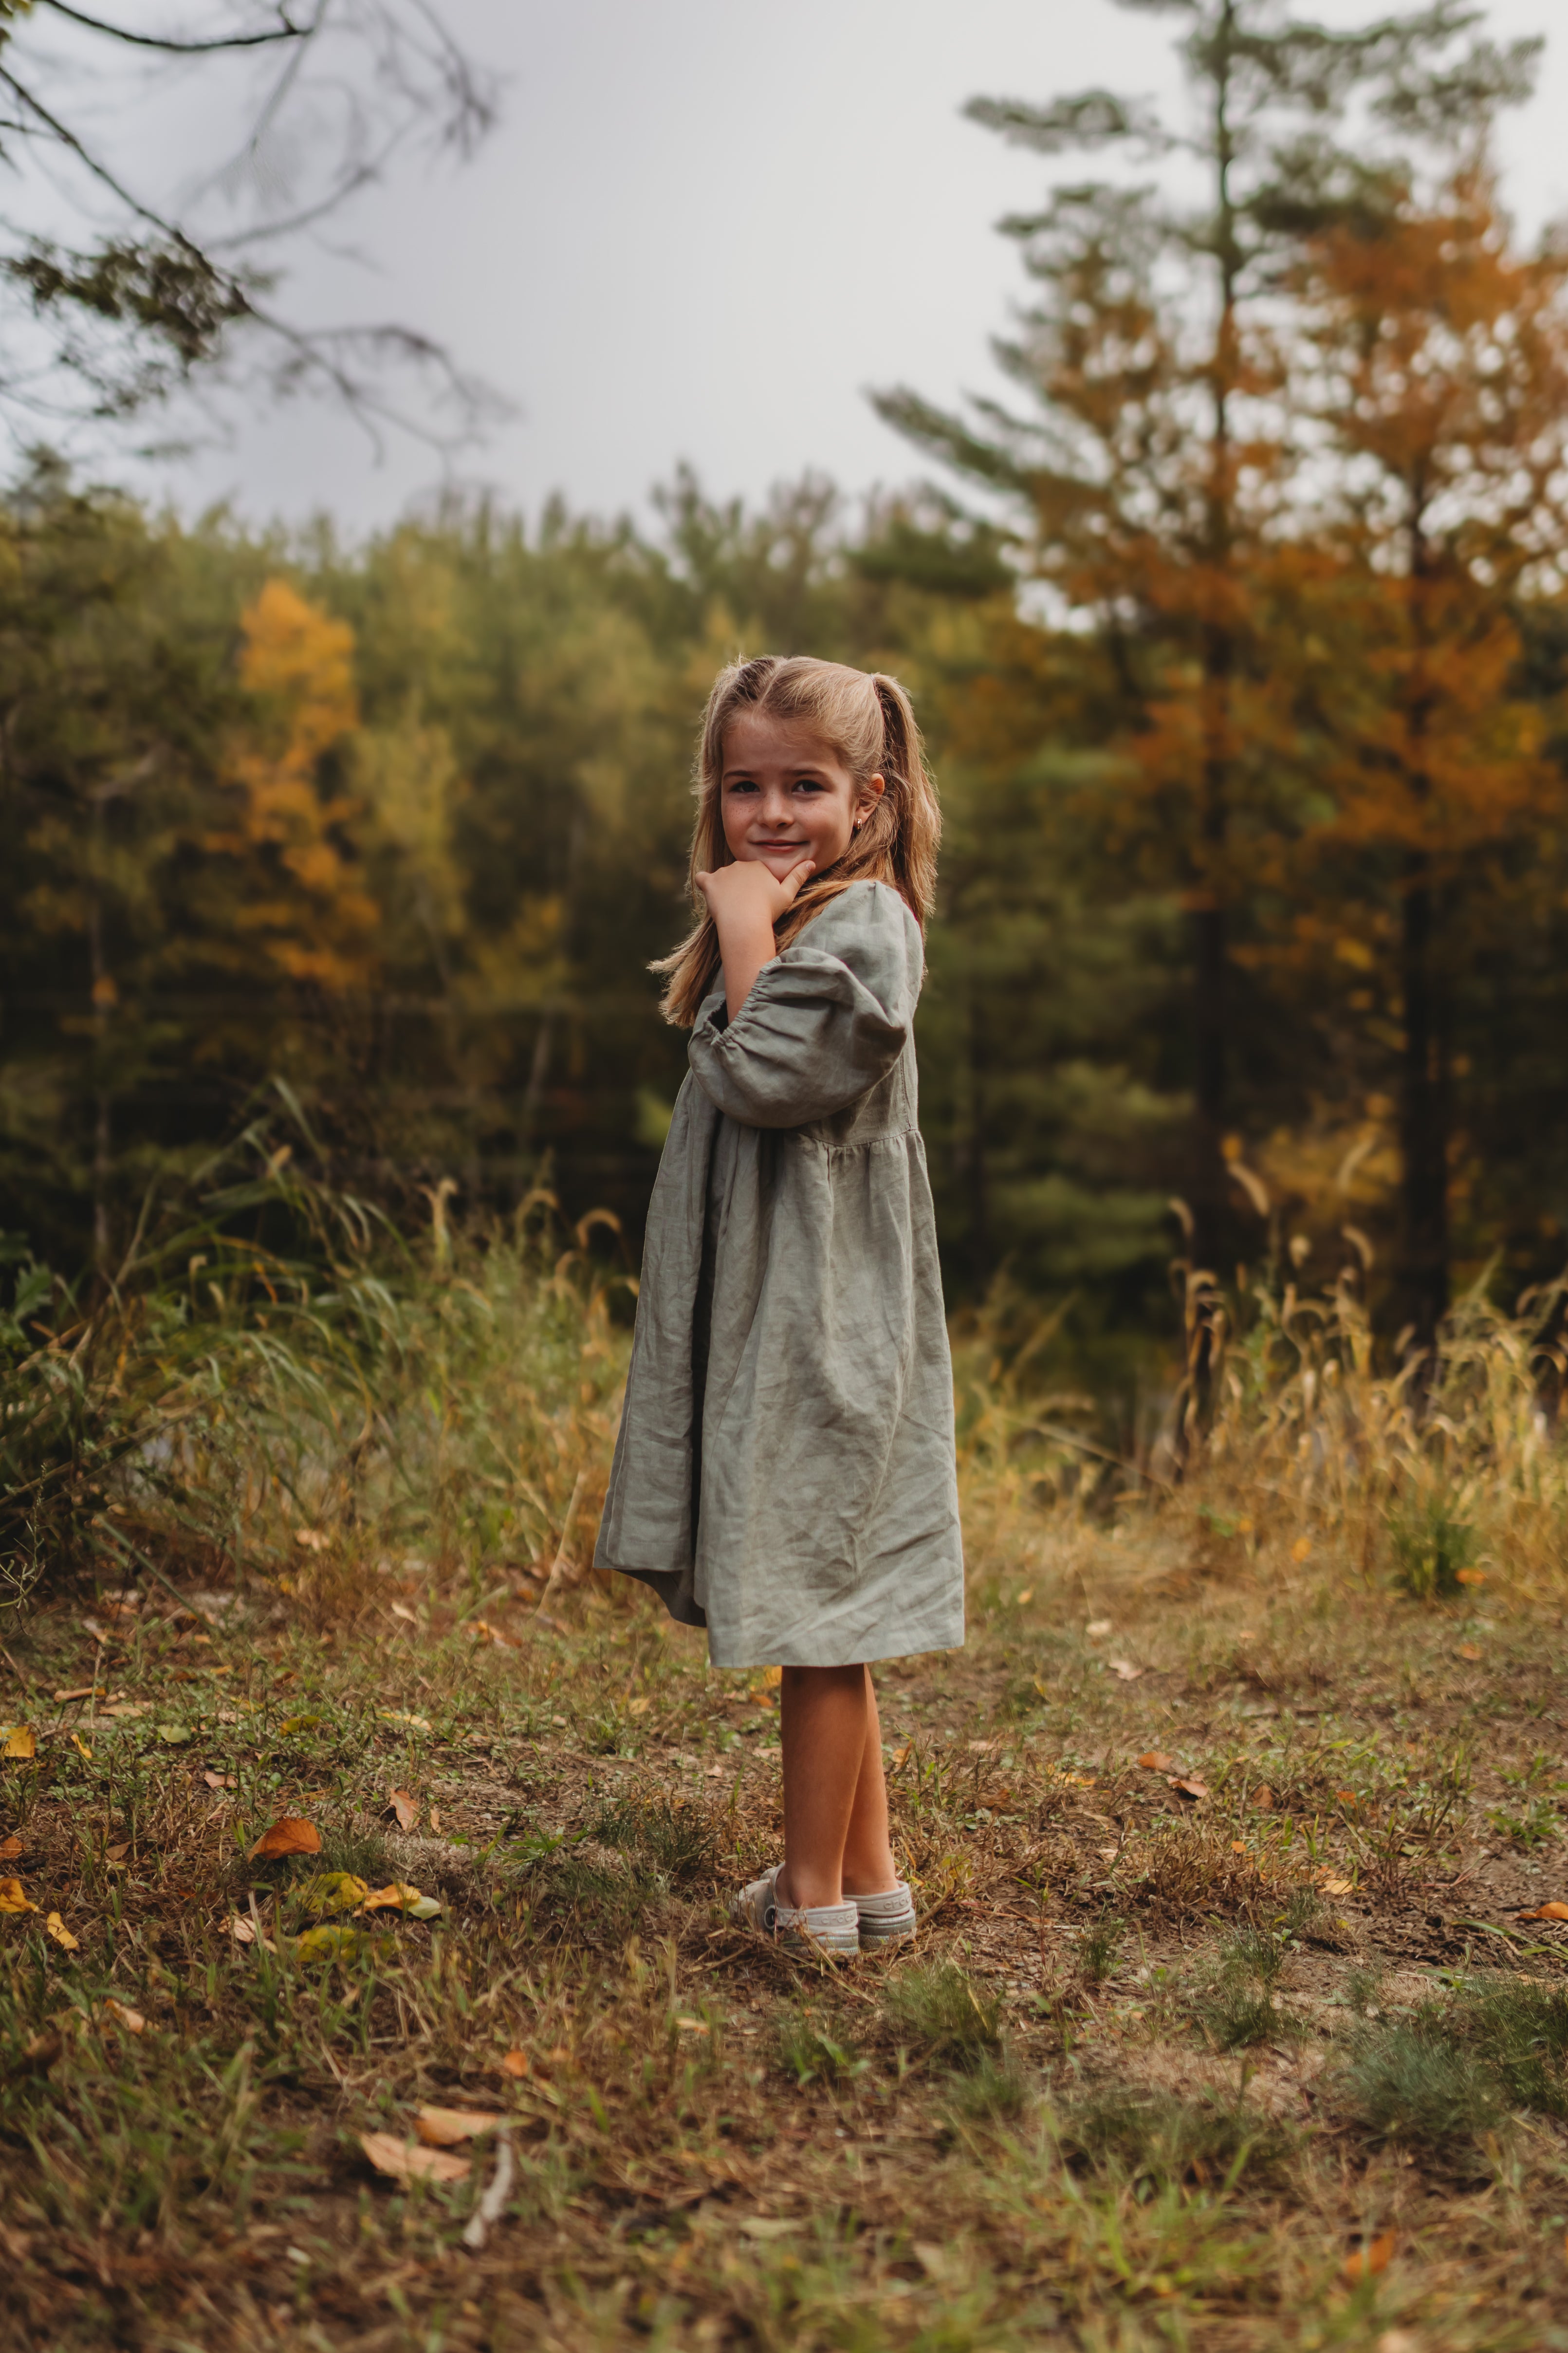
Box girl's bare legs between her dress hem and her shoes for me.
[779,1666,897,1908]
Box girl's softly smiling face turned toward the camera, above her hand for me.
[718,711,883,880]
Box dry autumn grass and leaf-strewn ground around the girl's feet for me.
[12,1214,1568,2353]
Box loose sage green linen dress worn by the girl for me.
[593,882,963,1666]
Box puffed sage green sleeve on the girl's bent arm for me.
[690,882,923,1127]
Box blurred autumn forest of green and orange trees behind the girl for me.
[0,151,1568,1388]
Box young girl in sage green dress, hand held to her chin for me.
[596,656,963,1953]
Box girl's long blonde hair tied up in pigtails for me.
[650,654,942,1028]
